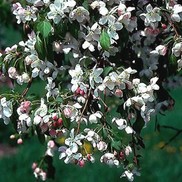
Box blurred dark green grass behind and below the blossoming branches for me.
[0,89,182,182]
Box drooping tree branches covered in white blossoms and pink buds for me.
[0,0,182,181]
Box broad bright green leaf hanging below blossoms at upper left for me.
[37,20,52,38]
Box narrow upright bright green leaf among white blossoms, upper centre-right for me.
[99,30,111,51]
